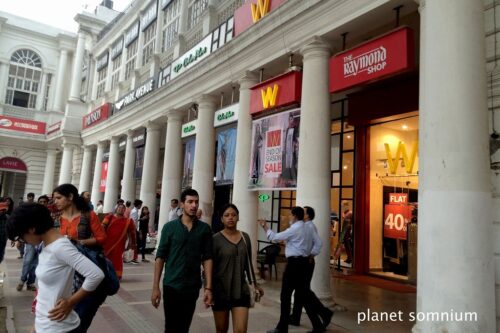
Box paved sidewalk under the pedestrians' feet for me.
[0,248,415,333]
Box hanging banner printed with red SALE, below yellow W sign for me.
[248,109,300,190]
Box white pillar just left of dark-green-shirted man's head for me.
[157,113,182,240]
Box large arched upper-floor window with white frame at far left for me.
[5,49,42,109]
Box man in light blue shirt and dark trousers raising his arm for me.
[258,207,323,333]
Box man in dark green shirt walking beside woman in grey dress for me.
[151,189,213,333]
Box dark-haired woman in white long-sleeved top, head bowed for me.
[7,203,104,333]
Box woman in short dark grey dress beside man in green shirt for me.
[212,204,264,333]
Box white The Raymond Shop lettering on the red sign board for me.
[344,46,387,77]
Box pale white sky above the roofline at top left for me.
[0,0,132,33]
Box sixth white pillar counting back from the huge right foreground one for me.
[139,122,160,226]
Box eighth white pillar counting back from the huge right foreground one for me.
[103,136,120,213]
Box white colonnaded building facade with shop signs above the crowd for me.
[0,0,500,332]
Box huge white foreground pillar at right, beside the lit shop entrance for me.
[413,0,492,333]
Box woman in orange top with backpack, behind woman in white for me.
[52,184,107,332]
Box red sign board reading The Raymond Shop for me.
[330,27,415,93]
